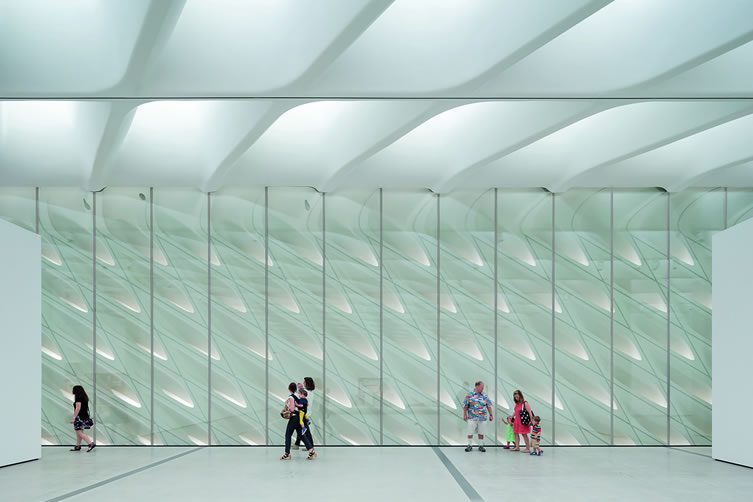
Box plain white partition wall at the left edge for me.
[0,220,42,466]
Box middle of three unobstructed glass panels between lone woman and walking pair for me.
[154,189,209,445]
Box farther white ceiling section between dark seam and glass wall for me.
[0,100,753,192]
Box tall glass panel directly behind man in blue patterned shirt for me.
[439,190,494,445]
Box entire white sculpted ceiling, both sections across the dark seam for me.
[0,0,753,191]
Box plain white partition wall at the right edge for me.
[711,220,753,467]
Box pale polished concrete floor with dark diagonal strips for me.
[0,447,753,502]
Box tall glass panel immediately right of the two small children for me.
[554,190,612,445]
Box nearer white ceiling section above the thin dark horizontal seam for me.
[5,0,753,97]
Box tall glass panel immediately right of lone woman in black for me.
[96,188,151,445]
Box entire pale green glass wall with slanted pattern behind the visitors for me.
[0,187,753,446]
